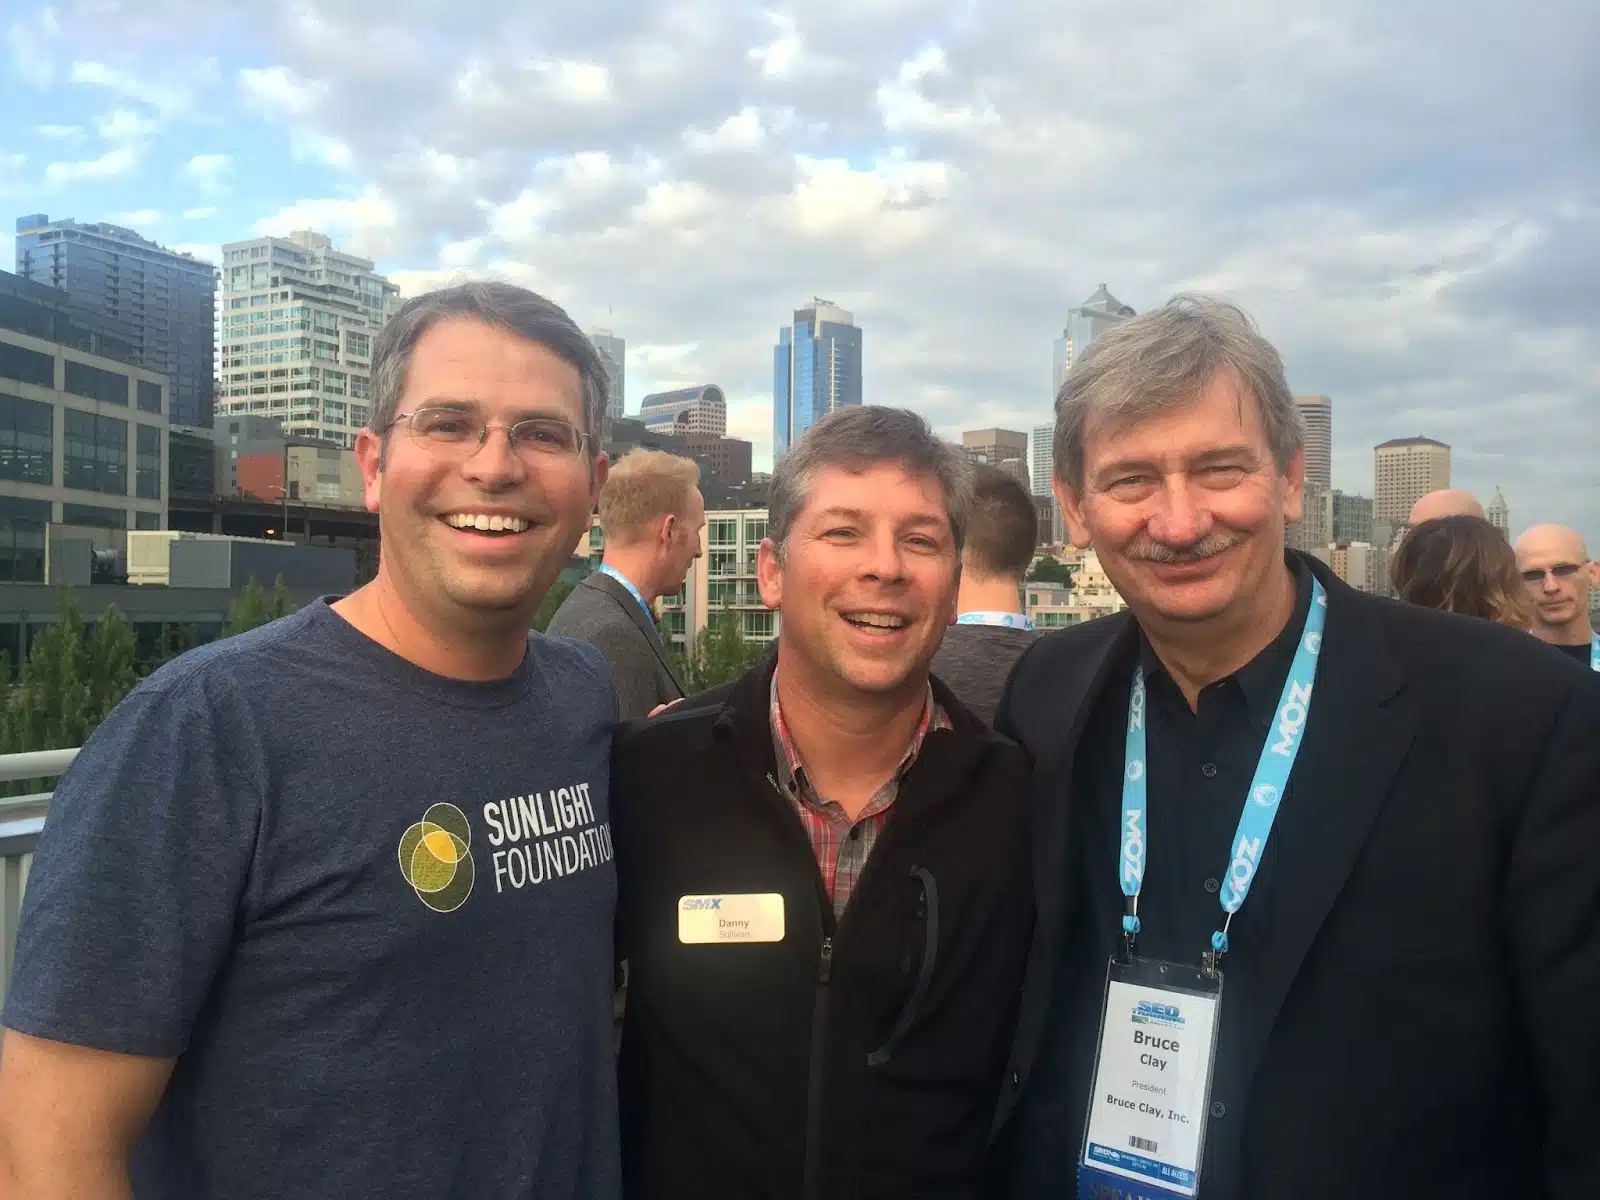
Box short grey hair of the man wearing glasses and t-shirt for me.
[370,282,610,458]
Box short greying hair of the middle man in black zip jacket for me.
[766,405,973,562]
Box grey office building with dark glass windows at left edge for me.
[0,272,168,582]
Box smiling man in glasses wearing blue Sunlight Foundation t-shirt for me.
[0,283,619,1200]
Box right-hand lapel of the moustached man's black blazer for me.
[1224,562,1416,1090]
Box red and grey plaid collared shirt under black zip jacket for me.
[770,670,950,917]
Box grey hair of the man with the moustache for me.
[1054,294,1306,490]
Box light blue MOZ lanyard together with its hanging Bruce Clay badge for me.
[1077,579,1328,1200]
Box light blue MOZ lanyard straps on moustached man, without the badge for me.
[1118,579,1328,970]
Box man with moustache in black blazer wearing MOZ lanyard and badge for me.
[994,298,1600,1200]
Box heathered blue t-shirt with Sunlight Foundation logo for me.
[0,602,621,1200]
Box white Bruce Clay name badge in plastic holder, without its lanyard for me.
[1078,958,1222,1200]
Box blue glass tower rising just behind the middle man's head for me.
[773,299,861,462]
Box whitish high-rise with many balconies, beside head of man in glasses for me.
[216,229,400,446]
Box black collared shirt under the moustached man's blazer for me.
[1064,557,1312,1195]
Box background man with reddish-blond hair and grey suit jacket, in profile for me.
[546,450,706,720]
